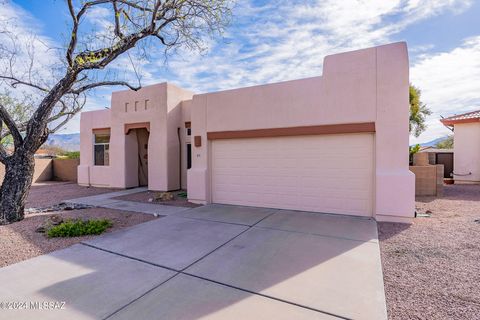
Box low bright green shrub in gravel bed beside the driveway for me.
[47,219,112,238]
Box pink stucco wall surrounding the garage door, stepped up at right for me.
[188,43,415,222]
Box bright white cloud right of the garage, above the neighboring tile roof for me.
[410,36,480,143]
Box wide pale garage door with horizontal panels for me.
[212,133,374,216]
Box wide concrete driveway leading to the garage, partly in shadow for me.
[0,205,387,320]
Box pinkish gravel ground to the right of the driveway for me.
[378,185,480,320]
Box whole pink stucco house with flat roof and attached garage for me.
[78,43,415,222]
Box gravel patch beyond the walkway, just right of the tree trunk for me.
[25,181,118,208]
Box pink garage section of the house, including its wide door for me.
[187,43,415,223]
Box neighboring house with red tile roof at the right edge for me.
[440,110,480,183]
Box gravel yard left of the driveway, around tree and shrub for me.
[0,183,156,267]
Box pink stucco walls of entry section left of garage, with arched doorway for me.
[78,83,193,191]
